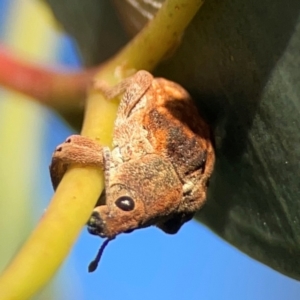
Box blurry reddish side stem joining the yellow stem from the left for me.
[0,45,97,112]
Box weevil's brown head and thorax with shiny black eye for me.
[88,154,182,238]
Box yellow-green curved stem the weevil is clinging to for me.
[0,0,202,300]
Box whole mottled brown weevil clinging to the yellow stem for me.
[50,71,215,244]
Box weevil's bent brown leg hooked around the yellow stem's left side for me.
[50,135,109,189]
